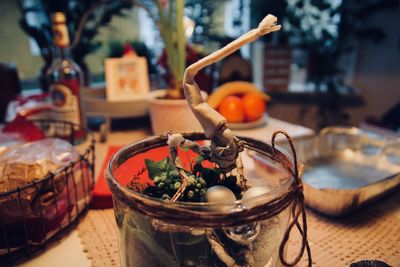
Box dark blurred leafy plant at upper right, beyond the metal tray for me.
[283,0,398,128]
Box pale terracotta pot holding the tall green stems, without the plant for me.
[148,89,207,135]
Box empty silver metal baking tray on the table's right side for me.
[280,127,400,216]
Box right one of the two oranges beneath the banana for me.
[242,92,266,122]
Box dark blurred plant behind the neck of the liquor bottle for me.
[19,0,132,90]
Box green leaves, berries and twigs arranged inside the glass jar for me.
[123,134,256,266]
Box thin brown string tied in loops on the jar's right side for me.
[271,131,312,266]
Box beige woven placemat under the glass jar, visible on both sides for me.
[78,204,400,267]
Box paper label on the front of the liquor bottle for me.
[50,84,80,127]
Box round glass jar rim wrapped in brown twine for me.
[105,132,295,227]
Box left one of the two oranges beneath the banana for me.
[217,95,245,122]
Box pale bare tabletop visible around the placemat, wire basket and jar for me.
[19,117,314,267]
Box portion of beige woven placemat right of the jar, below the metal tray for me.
[289,210,400,267]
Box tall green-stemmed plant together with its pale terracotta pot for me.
[135,0,206,134]
